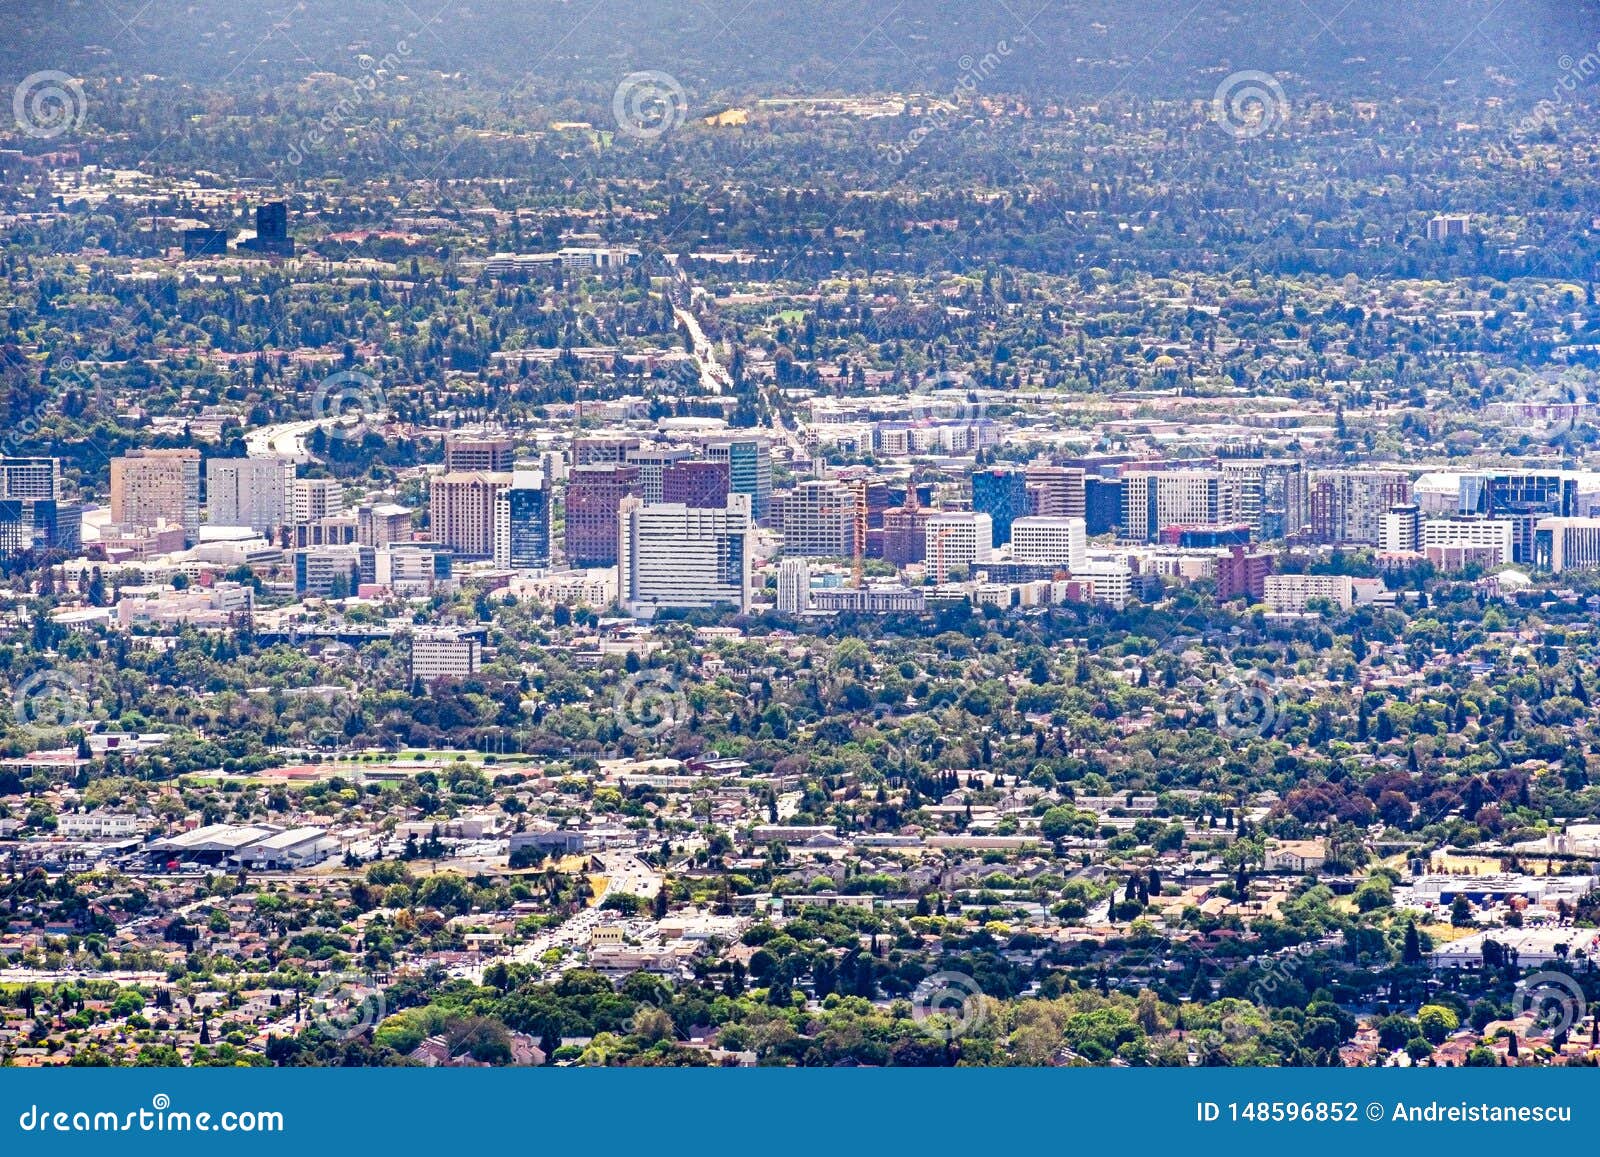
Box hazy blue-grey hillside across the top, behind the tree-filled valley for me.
[0,0,1600,102]
